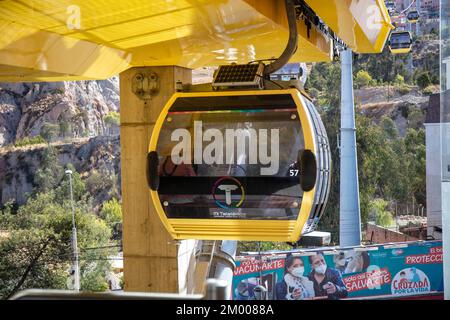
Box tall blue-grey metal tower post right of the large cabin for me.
[339,49,361,246]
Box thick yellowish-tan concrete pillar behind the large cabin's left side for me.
[120,66,195,293]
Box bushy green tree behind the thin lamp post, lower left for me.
[0,191,111,298]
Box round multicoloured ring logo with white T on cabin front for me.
[211,177,245,209]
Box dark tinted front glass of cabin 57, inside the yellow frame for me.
[157,95,304,219]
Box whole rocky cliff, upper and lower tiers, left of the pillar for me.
[0,77,120,206]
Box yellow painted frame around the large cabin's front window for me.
[149,89,317,241]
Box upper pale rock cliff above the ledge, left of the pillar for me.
[0,77,119,147]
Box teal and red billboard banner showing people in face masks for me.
[233,241,443,300]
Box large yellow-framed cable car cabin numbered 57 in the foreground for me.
[147,89,331,241]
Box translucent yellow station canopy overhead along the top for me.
[0,0,390,81]
